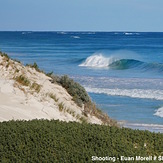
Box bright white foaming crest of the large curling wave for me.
[79,54,116,68]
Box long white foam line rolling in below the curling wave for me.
[85,87,163,100]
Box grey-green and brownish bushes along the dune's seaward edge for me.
[48,73,115,126]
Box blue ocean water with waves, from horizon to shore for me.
[0,31,163,132]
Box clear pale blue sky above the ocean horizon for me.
[0,0,163,32]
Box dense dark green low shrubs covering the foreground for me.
[0,120,163,162]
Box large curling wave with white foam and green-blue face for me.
[79,54,163,72]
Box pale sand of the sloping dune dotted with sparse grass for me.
[0,56,102,124]
